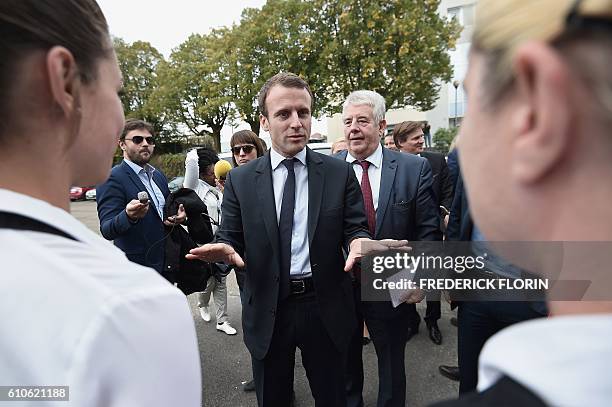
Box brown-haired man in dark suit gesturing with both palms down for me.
[189,73,405,407]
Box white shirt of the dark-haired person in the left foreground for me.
[0,189,201,407]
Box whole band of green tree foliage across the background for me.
[116,0,460,143]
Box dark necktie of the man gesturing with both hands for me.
[278,158,295,300]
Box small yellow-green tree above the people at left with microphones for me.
[151,32,232,151]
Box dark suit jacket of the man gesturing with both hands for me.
[216,148,369,359]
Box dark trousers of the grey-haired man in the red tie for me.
[365,313,410,407]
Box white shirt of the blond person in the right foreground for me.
[478,314,612,407]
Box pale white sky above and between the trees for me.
[98,0,327,148]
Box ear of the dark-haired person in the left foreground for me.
[46,46,81,117]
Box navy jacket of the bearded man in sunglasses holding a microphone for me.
[96,161,170,274]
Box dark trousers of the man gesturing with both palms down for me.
[253,295,346,407]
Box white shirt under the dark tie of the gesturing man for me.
[270,147,312,278]
